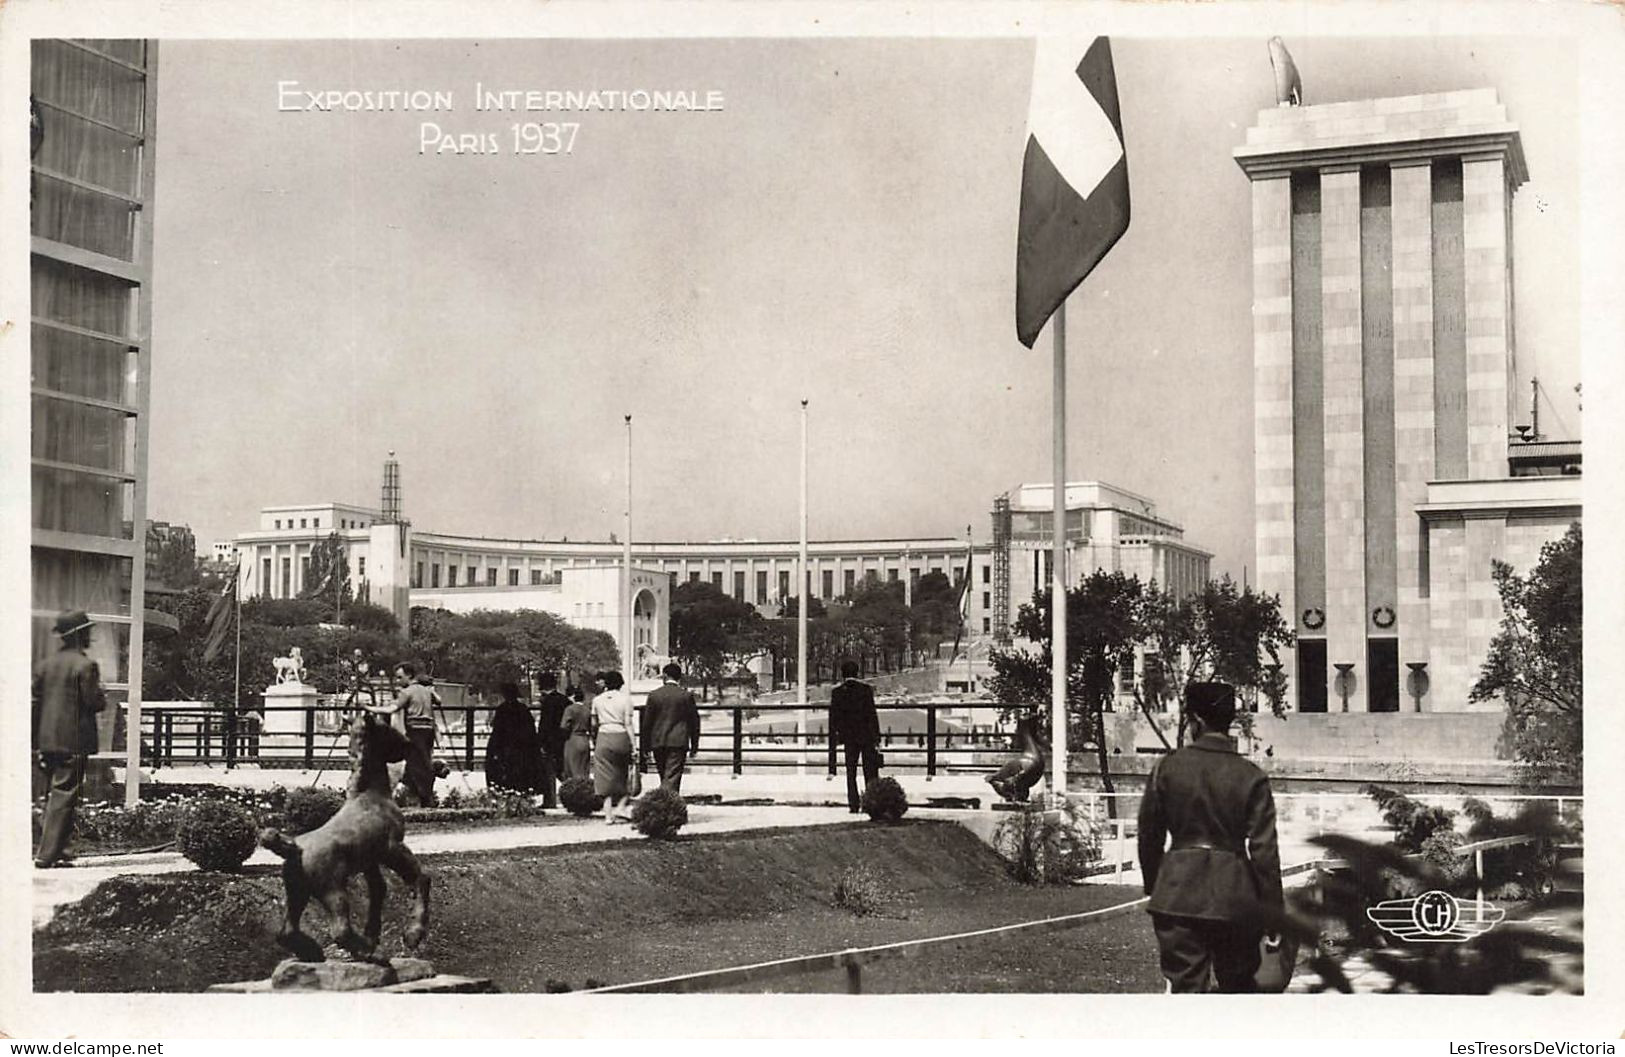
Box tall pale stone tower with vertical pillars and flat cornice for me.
[1235,89,1578,712]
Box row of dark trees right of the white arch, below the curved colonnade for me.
[671,572,962,689]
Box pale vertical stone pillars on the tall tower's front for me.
[1251,153,1511,711]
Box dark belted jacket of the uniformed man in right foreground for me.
[1139,733,1281,922]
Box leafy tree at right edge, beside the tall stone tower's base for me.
[1469,522,1584,782]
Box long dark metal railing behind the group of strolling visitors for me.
[141,699,1012,777]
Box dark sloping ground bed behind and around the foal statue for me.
[34,821,1144,990]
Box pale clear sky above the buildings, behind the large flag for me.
[150,33,1581,577]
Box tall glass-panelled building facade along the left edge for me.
[29,41,161,748]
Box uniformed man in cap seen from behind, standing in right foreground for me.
[1139,683,1282,992]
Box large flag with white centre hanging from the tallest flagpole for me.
[1016,37,1129,348]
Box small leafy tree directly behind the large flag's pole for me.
[991,569,1146,792]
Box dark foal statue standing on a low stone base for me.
[260,707,429,961]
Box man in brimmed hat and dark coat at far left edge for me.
[34,610,107,868]
